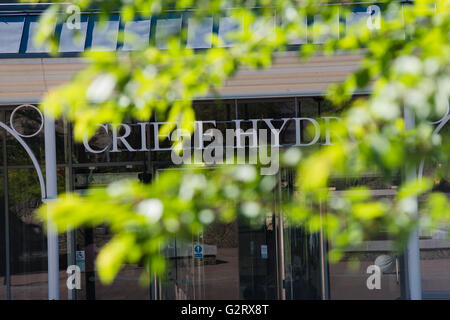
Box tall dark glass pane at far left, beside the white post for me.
[8,168,48,300]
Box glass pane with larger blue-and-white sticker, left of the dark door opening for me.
[163,222,239,300]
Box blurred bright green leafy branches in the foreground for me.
[28,0,450,282]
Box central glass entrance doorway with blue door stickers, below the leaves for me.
[156,169,328,300]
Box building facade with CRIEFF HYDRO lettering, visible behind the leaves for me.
[0,4,450,300]
